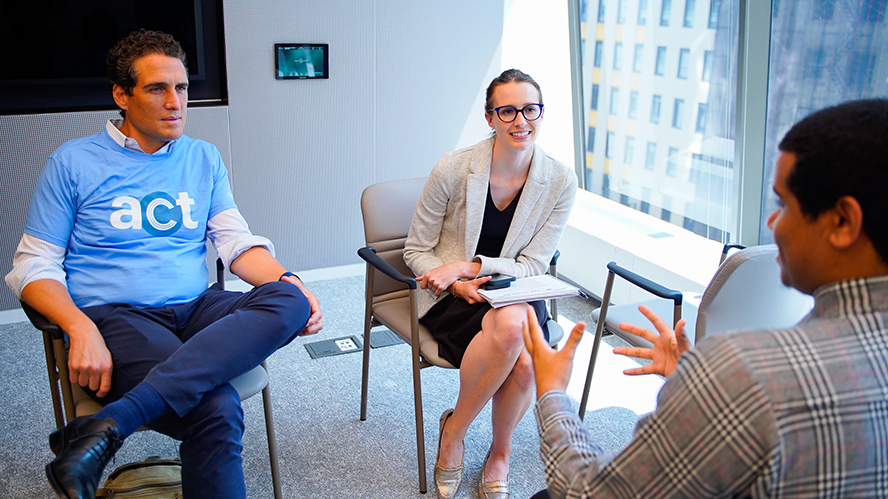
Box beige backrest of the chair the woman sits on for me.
[361,177,426,299]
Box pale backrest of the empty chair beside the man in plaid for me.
[695,244,813,344]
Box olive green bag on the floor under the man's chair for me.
[96,456,182,499]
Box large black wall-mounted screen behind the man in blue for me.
[0,0,228,114]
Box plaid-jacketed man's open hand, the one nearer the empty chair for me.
[614,305,691,376]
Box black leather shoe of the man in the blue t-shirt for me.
[46,416,123,499]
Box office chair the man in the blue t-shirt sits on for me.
[21,259,283,499]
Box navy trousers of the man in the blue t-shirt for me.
[83,282,311,498]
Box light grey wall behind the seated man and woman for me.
[0,0,573,310]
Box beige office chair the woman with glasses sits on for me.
[358,177,564,494]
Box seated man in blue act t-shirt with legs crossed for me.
[6,30,323,498]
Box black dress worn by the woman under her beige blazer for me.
[420,186,549,367]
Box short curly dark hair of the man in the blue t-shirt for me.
[105,29,188,99]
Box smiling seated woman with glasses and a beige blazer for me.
[404,69,577,499]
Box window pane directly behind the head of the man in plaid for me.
[756,0,888,242]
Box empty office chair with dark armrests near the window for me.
[580,244,813,419]
